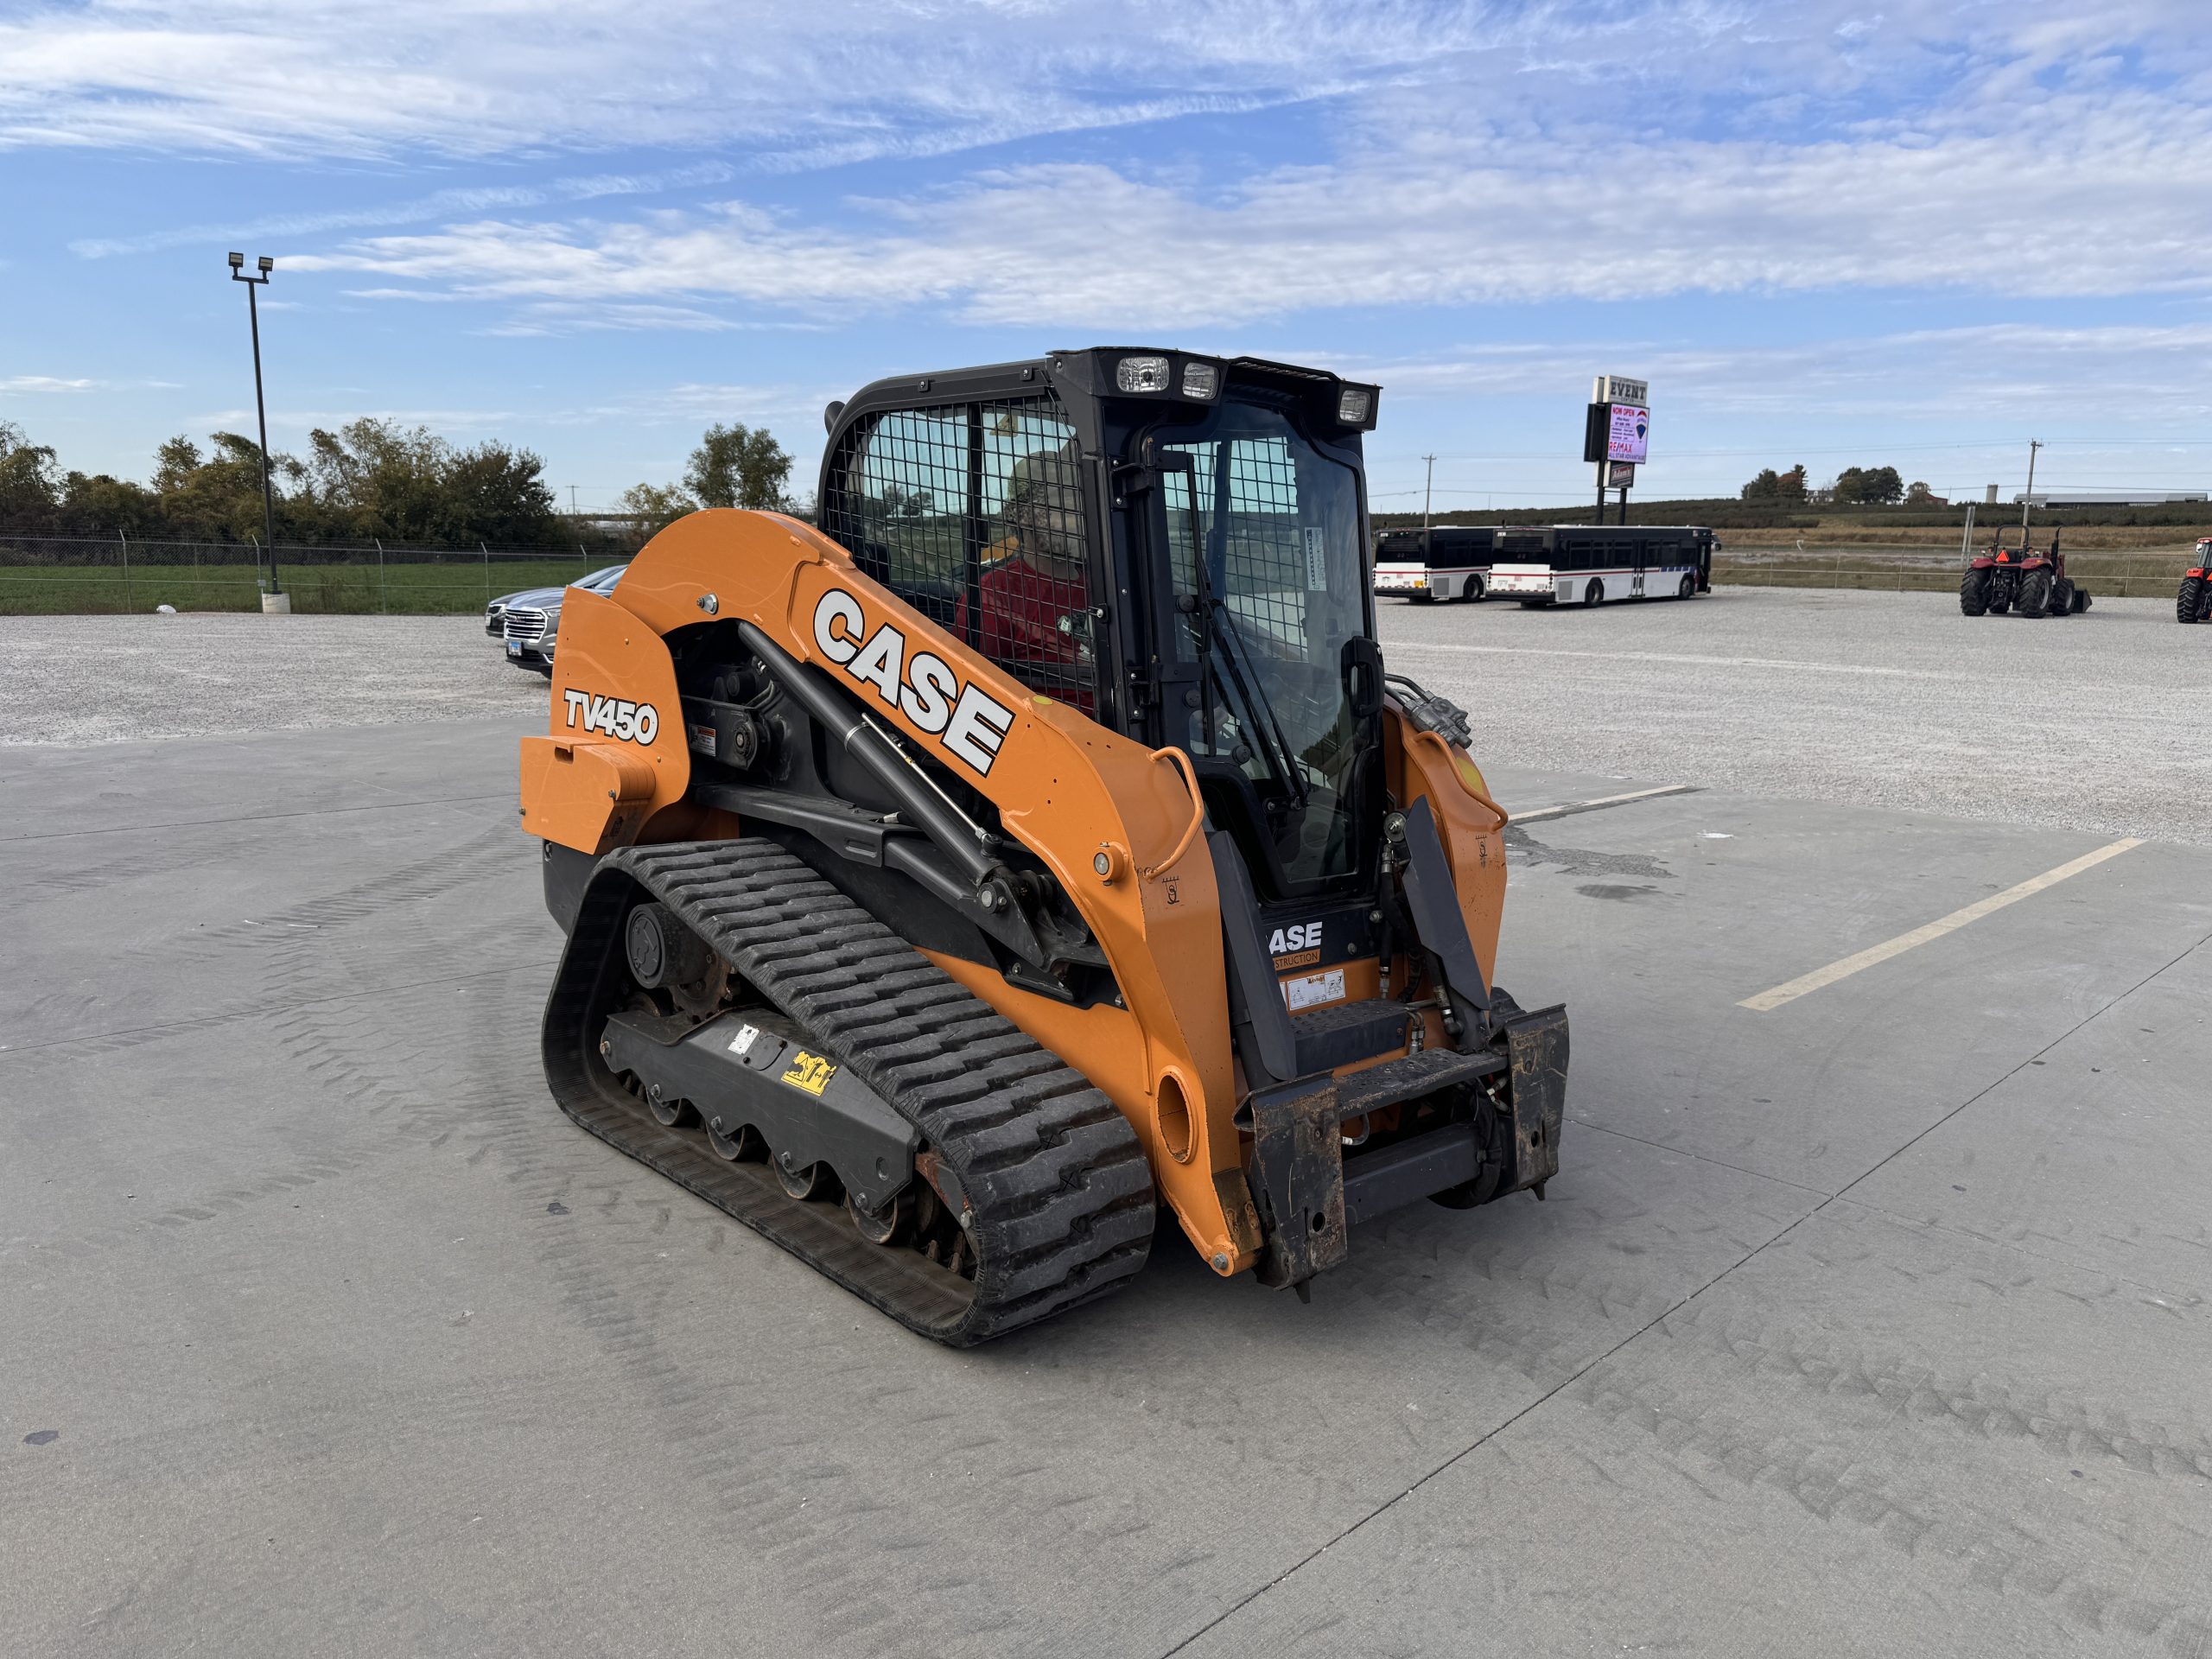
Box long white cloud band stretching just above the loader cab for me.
[276,93,2212,329]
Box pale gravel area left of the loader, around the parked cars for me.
[0,613,546,747]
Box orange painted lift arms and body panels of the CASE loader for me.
[524,511,1504,1274]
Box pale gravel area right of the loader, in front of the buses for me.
[1378,588,2212,842]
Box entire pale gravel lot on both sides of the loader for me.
[0,588,2212,842]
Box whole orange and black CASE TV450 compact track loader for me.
[522,349,1566,1343]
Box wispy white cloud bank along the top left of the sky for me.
[0,0,1484,168]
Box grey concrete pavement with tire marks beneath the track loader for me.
[0,719,2212,1655]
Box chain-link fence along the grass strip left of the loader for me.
[0,536,628,615]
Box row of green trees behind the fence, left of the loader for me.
[0,418,791,546]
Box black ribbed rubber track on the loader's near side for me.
[544,838,1153,1347]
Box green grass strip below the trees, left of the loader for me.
[0,556,611,617]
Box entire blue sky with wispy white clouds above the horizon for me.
[0,0,2212,519]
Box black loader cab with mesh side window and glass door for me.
[818,347,1385,902]
